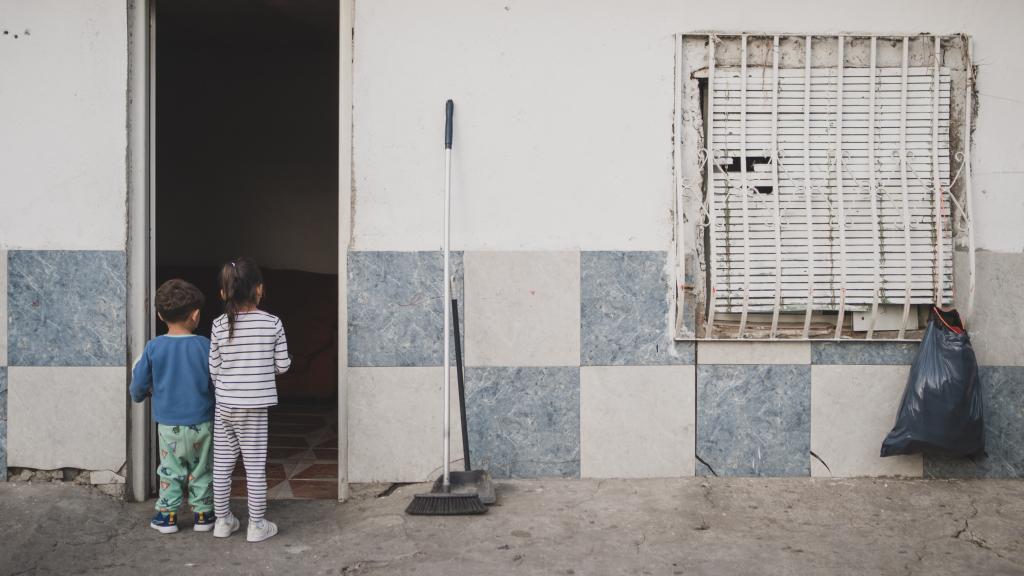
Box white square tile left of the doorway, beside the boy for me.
[7,367,128,470]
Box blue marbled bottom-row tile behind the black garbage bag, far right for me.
[925,366,1024,478]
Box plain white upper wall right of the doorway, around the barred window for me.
[352,0,1024,251]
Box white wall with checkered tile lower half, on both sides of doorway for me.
[0,0,1024,482]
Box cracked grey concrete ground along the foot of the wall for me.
[0,478,1024,575]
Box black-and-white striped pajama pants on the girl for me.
[213,404,267,521]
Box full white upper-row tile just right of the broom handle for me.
[465,252,580,367]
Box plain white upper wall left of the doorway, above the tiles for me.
[0,0,128,250]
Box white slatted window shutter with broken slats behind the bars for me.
[708,67,953,313]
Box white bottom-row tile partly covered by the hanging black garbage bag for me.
[811,365,924,478]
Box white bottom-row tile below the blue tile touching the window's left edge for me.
[580,366,695,478]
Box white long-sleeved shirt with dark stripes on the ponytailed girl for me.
[210,311,292,408]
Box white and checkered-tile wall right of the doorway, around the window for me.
[348,0,1024,481]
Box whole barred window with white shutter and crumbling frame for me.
[676,35,970,339]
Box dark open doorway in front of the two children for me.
[153,0,339,499]
